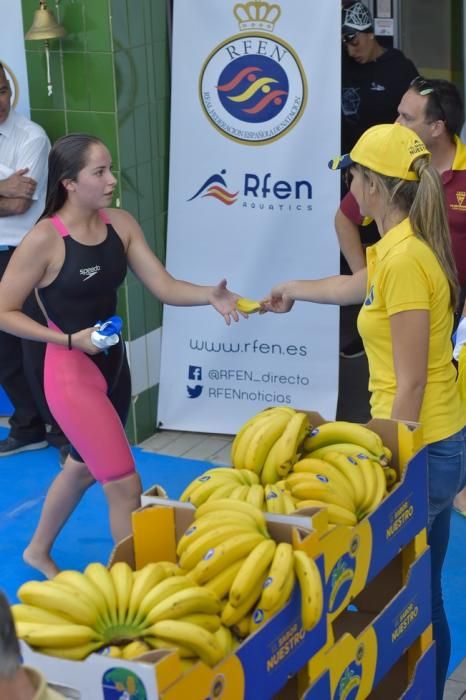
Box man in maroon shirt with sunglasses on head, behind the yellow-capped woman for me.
[335,76,466,516]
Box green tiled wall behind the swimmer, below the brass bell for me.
[21,0,170,442]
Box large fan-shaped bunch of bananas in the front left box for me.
[12,562,224,665]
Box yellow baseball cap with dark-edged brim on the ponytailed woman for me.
[328,123,430,180]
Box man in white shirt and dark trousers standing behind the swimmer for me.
[0,64,65,457]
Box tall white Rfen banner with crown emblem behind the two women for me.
[158,0,341,433]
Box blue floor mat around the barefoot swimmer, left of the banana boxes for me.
[0,429,211,601]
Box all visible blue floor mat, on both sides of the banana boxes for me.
[0,428,466,673]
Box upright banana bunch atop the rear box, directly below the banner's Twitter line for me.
[231,406,310,484]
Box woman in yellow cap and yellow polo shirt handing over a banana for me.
[262,124,466,700]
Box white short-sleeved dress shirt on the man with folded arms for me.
[0,109,50,246]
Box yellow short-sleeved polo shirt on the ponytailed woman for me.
[358,218,466,444]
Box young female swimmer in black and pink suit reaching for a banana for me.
[0,134,246,577]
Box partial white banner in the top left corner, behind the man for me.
[0,0,32,117]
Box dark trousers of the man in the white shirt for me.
[0,250,60,442]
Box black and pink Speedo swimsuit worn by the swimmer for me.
[38,211,135,483]
